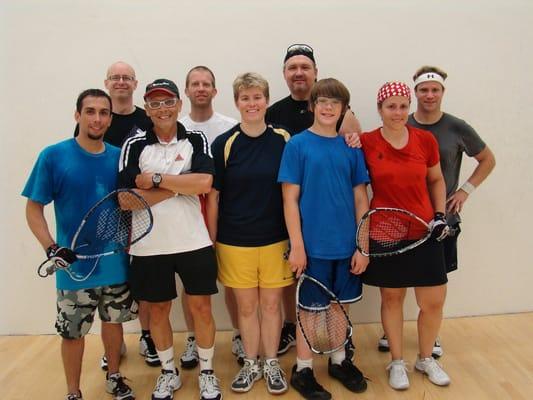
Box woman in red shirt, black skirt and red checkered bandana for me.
[361,82,450,390]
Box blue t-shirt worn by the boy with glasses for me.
[278,130,369,260]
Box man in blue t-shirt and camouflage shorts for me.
[22,89,135,400]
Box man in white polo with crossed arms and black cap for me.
[119,79,222,400]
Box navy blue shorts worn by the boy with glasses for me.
[299,257,363,309]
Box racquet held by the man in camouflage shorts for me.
[37,189,154,281]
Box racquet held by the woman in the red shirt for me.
[357,207,431,257]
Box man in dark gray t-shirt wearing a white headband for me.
[378,66,496,358]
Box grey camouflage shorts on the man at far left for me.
[56,284,138,339]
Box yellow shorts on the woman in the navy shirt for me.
[215,240,294,289]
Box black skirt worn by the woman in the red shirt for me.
[362,239,448,288]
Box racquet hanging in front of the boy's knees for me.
[296,274,353,354]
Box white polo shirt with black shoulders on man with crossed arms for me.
[119,123,214,256]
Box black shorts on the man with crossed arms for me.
[129,246,218,303]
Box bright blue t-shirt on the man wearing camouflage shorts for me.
[22,139,128,290]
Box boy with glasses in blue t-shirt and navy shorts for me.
[278,78,369,399]
